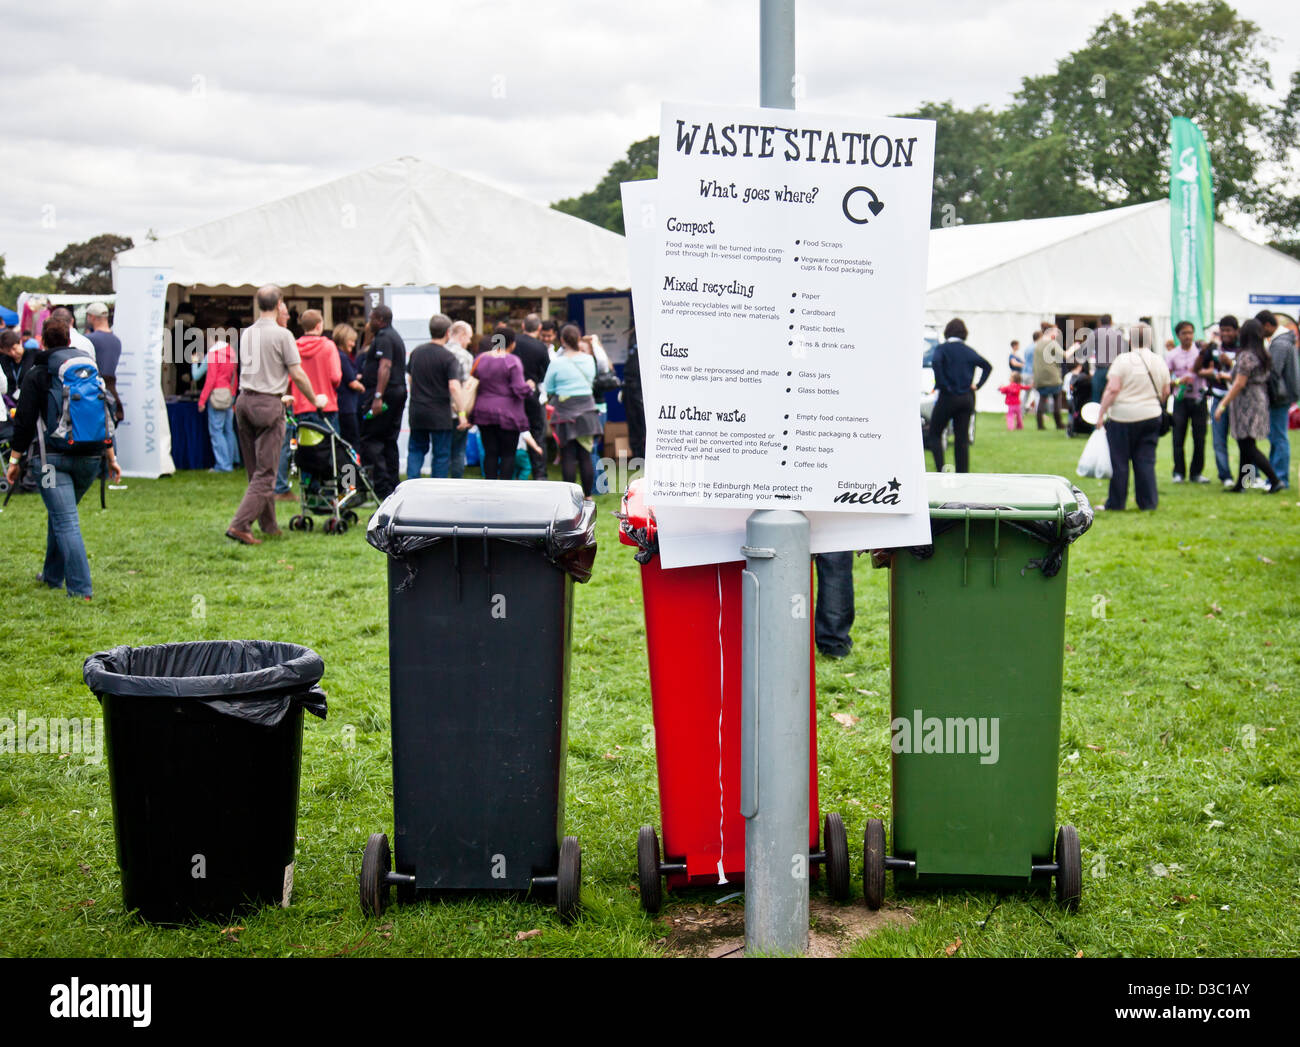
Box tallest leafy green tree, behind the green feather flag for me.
[1006,0,1274,217]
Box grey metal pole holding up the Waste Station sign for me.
[741,0,811,955]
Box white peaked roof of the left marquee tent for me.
[117,156,628,314]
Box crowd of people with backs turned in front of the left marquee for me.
[218,285,624,545]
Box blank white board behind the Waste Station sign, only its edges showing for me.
[621,179,931,568]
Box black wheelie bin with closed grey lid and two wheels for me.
[360,480,595,920]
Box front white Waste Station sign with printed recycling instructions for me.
[633,104,935,514]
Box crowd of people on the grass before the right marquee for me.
[930,310,1300,510]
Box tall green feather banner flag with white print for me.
[1169,116,1214,338]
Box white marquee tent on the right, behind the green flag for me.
[926,200,1300,411]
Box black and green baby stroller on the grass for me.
[287,416,380,535]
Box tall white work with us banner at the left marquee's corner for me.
[113,265,176,479]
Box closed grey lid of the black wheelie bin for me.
[376,479,584,538]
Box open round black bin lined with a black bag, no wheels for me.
[85,640,325,923]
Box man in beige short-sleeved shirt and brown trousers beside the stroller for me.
[226,284,326,545]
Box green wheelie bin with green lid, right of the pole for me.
[863,473,1092,909]
